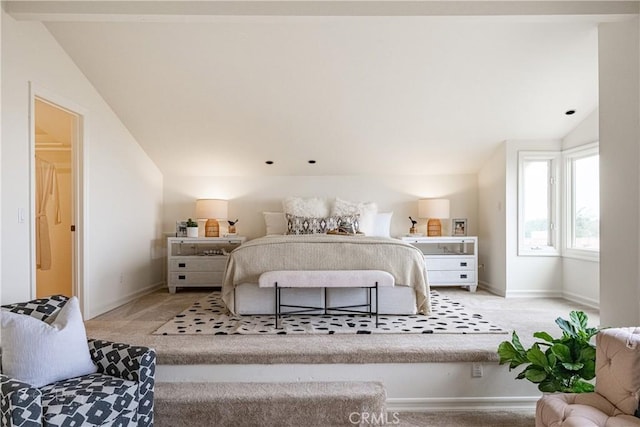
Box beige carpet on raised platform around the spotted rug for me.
[86,288,599,364]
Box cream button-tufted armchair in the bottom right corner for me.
[536,328,640,427]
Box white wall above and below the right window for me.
[562,109,600,307]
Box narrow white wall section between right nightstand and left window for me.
[478,143,507,296]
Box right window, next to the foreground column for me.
[563,144,600,258]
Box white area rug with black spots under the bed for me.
[154,291,508,335]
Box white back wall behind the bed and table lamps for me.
[164,175,478,238]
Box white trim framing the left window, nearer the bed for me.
[518,151,561,256]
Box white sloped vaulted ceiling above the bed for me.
[7,2,620,176]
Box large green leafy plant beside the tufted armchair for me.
[498,311,600,393]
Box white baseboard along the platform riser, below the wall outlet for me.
[387,396,540,412]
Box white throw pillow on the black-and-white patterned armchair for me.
[0,297,98,387]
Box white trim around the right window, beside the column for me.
[562,142,600,262]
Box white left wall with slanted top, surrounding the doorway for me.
[1,12,163,317]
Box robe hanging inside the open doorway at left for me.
[36,156,62,270]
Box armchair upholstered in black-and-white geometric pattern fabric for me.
[0,295,156,427]
